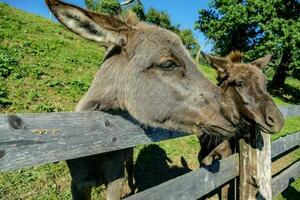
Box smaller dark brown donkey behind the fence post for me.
[198,51,284,198]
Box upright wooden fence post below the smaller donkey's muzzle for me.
[239,127,272,200]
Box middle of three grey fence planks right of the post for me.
[271,132,300,158]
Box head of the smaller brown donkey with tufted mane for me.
[202,51,284,133]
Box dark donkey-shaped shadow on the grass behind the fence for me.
[134,144,191,192]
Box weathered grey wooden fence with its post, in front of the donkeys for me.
[0,106,300,200]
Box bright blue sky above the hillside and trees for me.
[0,0,211,51]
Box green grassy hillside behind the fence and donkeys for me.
[0,3,300,200]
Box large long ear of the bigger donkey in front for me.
[46,0,131,47]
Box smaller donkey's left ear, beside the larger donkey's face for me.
[201,51,230,79]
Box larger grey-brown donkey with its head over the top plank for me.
[46,0,239,199]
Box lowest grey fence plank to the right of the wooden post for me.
[272,161,300,197]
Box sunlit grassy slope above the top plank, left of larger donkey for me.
[0,4,104,113]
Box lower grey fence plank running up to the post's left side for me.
[124,154,239,200]
